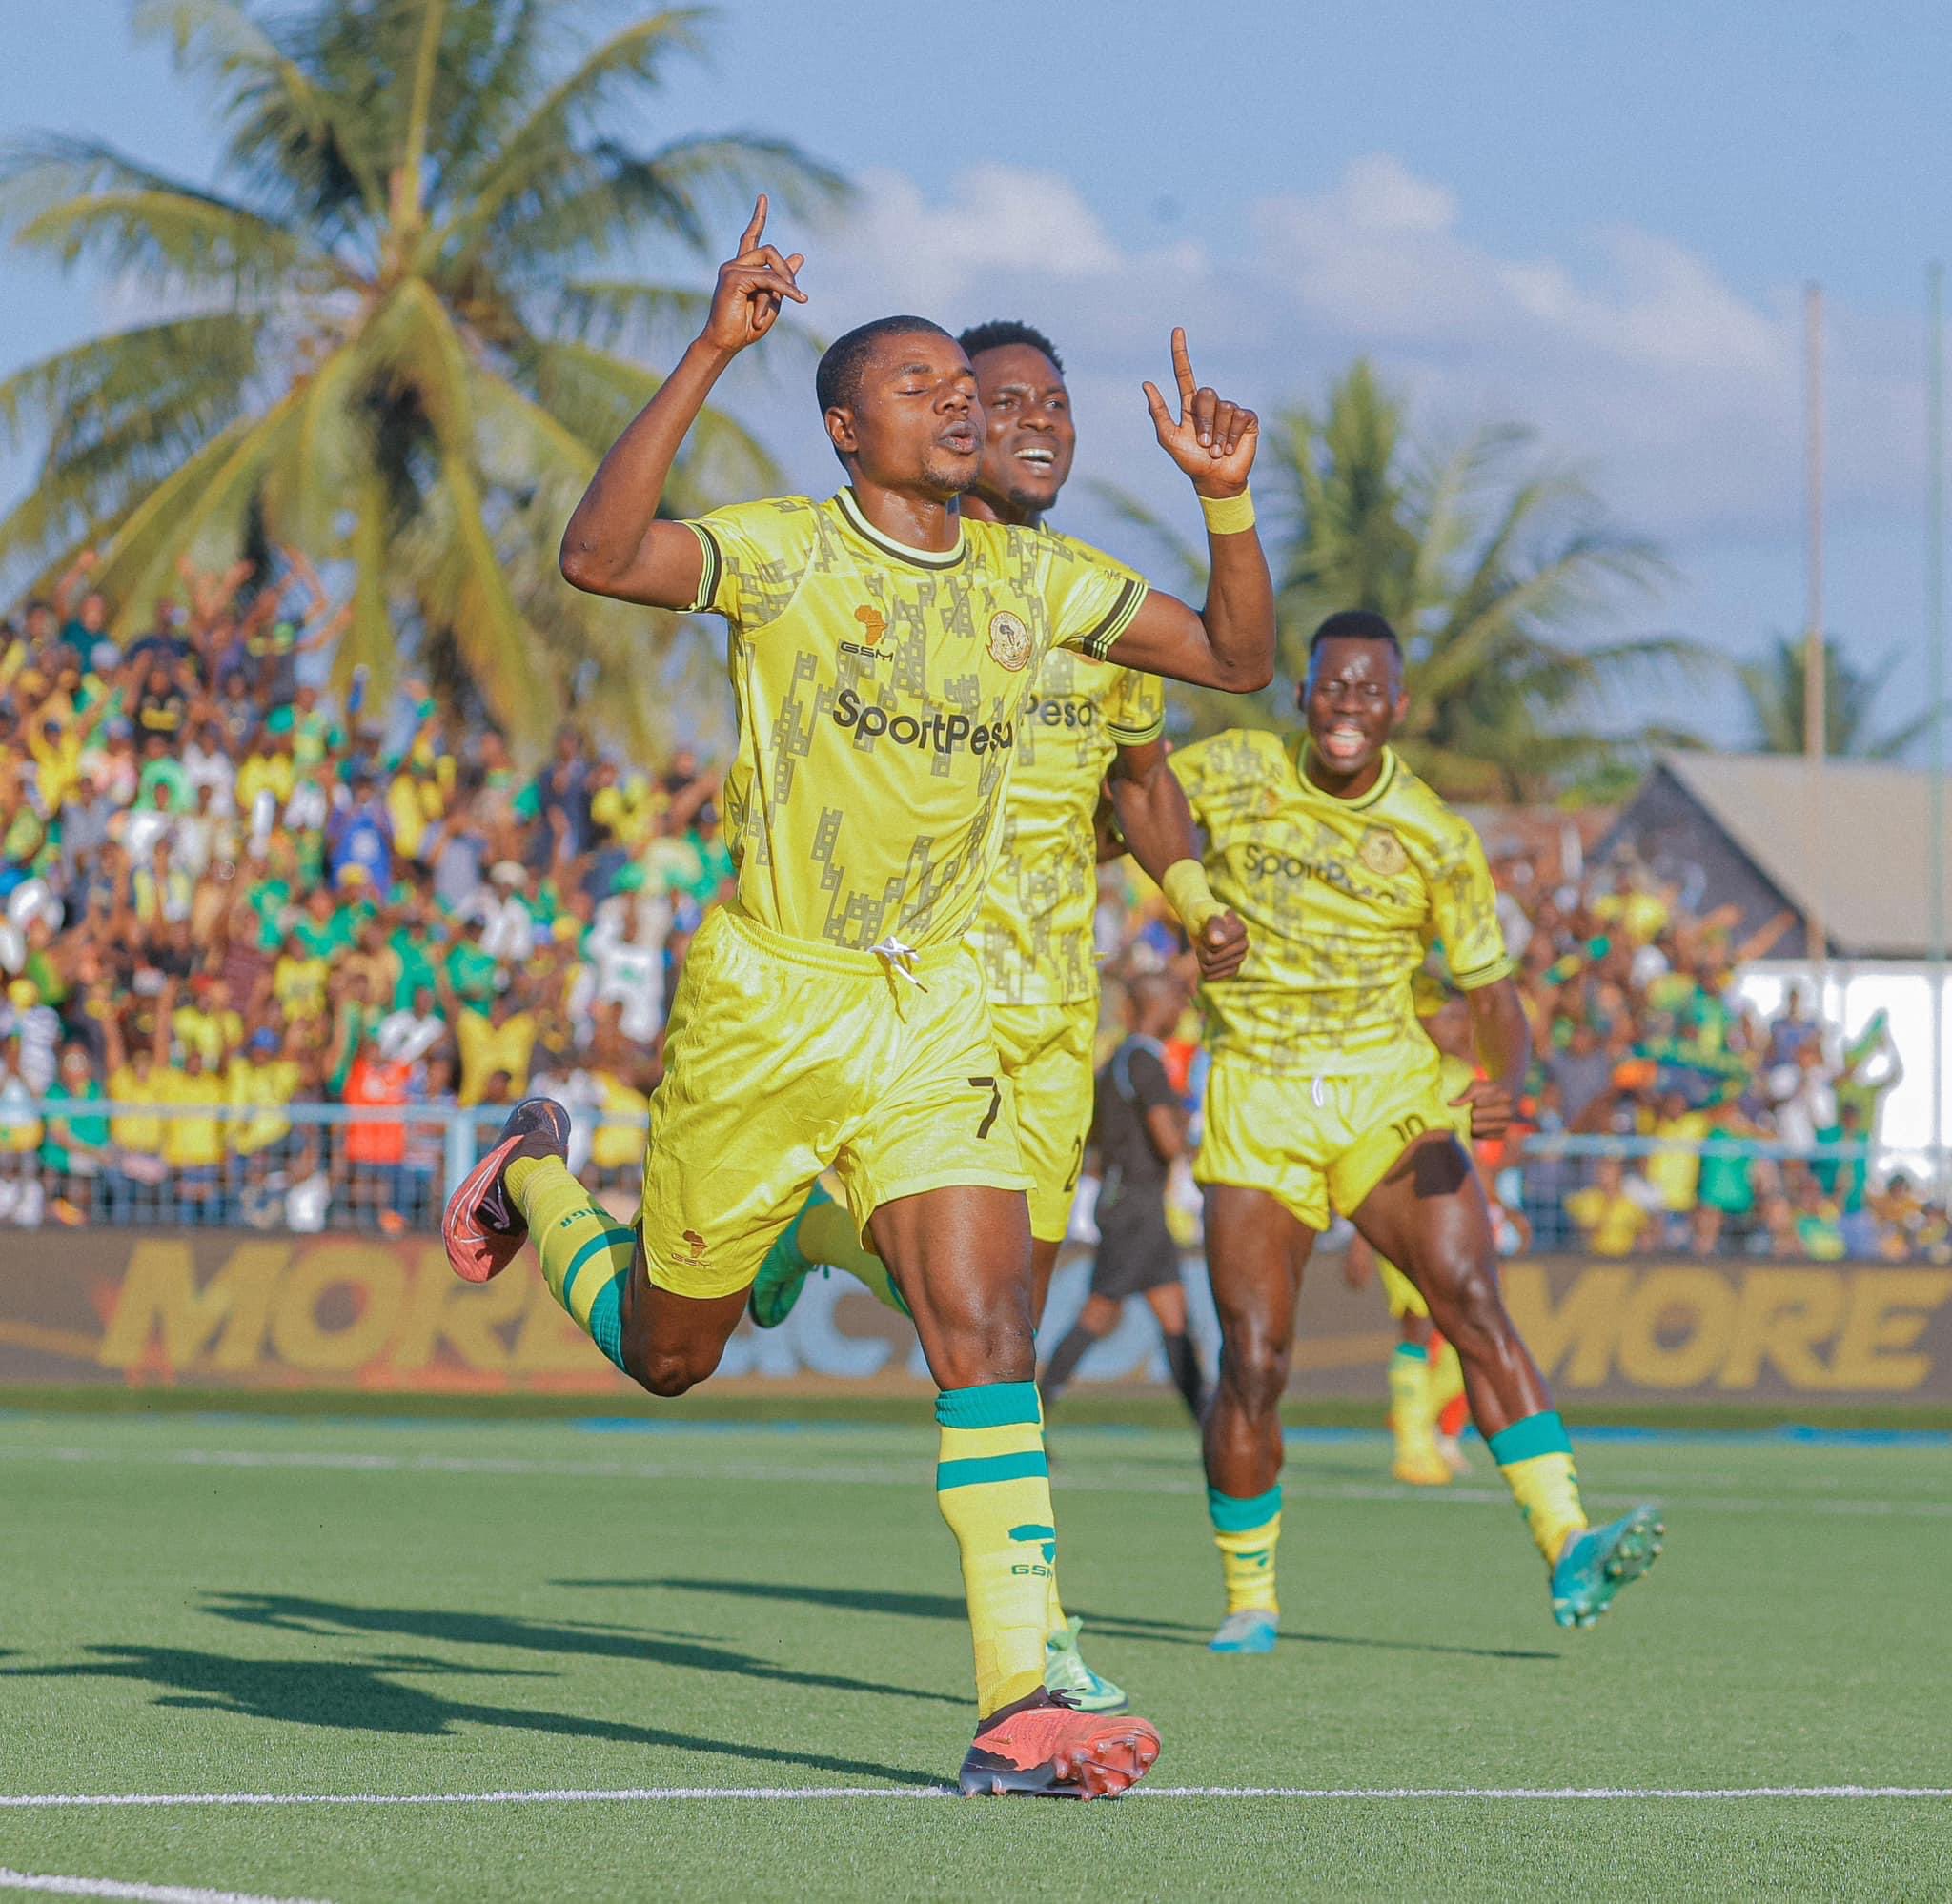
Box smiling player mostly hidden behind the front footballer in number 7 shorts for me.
[751,320,1248,1712]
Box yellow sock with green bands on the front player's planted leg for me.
[935,1381,1058,1719]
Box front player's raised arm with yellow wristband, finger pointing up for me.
[1114,330,1274,695]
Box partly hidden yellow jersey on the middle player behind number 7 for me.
[972,531,1166,1004]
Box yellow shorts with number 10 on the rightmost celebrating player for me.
[1192,1043,1470,1229]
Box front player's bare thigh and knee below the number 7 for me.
[868,1185,1036,1389]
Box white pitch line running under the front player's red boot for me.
[0,1785,1952,1810]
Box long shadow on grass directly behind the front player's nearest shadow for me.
[203,1594,965,1705]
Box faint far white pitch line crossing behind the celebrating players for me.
[11,1448,1952,1520]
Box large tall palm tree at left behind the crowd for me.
[0,0,844,741]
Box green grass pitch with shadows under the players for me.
[0,1407,1952,1904]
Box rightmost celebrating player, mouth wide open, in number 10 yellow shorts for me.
[1173,611,1663,1652]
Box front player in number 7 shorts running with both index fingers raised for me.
[445,199,1274,1796]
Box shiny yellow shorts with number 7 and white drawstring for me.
[642,907,1030,1297]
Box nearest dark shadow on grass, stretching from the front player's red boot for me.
[0,1647,933,1785]
